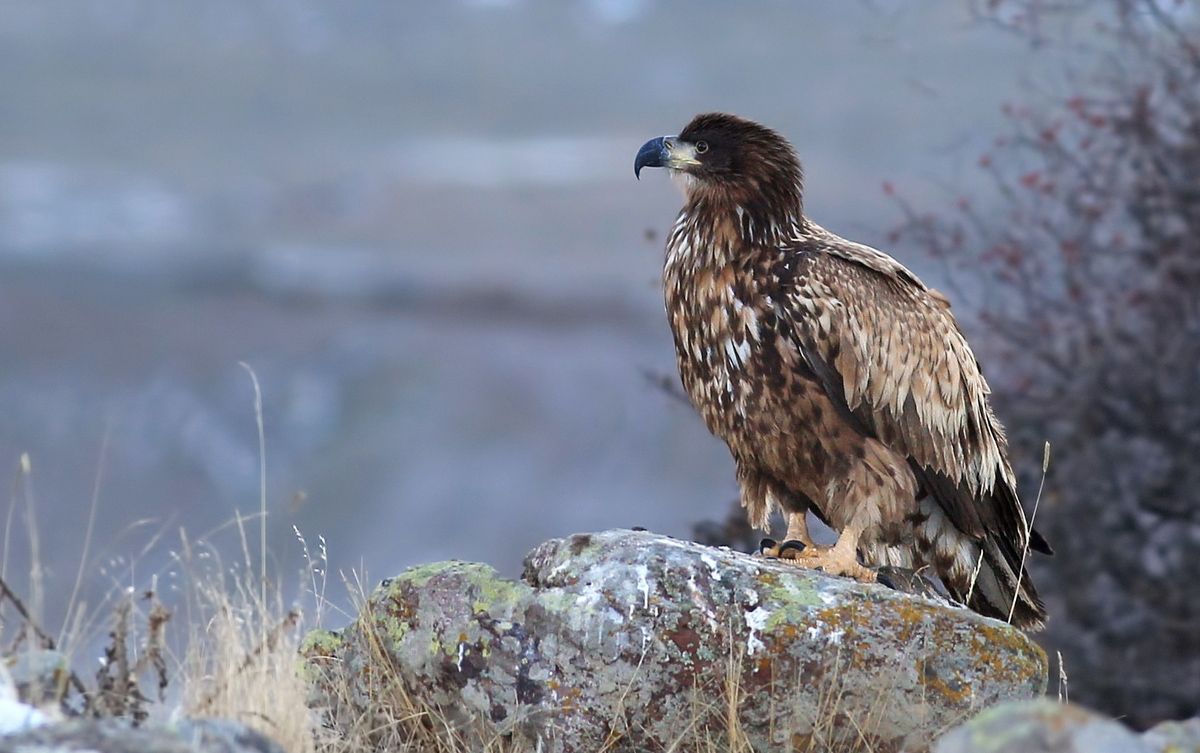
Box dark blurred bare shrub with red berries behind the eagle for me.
[894,0,1200,725]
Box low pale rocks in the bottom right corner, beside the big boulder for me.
[934,698,1200,753]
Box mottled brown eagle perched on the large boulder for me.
[634,113,1051,629]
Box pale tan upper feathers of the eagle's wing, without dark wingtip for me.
[788,232,998,484]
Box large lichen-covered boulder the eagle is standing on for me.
[307,531,1046,753]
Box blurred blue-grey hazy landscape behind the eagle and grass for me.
[0,0,1200,719]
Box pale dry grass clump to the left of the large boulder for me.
[0,438,323,753]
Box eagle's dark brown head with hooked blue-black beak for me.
[634,113,802,218]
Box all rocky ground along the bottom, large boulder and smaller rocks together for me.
[0,530,1200,753]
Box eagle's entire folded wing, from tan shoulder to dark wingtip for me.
[784,228,1050,614]
